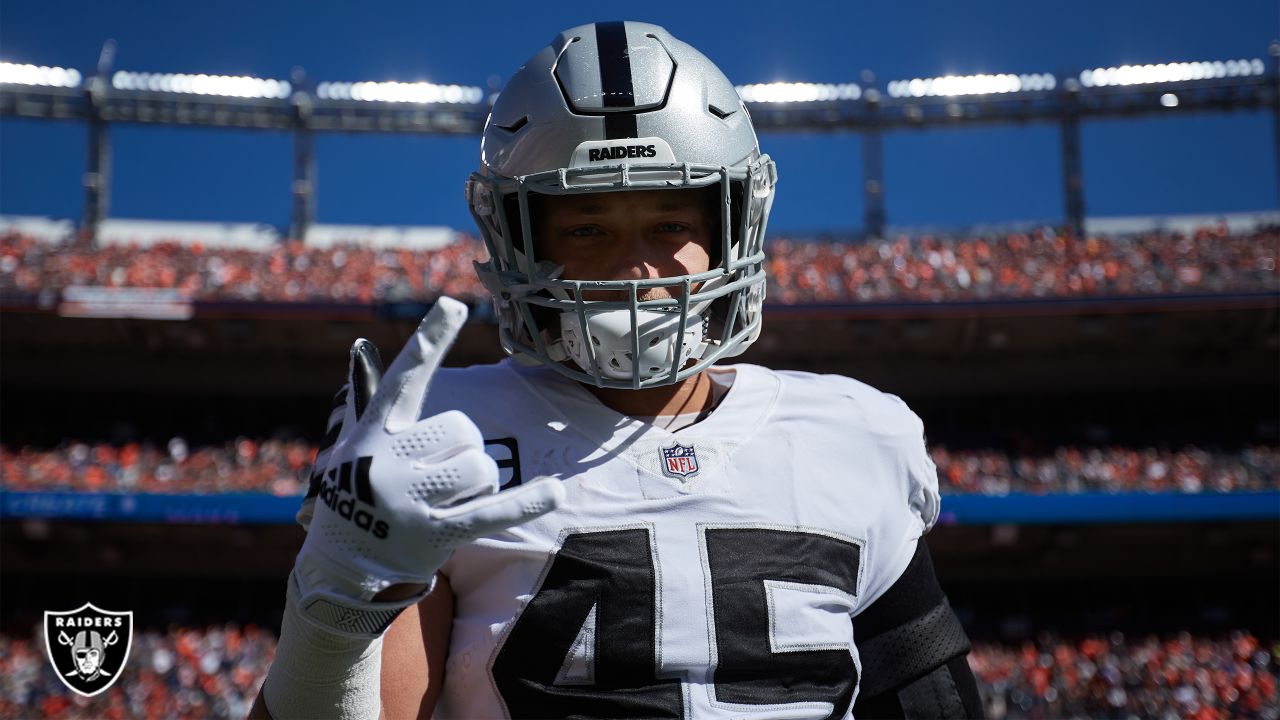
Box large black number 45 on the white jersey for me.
[493,528,860,719]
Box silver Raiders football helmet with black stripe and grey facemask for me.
[467,22,777,388]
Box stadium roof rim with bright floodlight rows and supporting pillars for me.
[0,42,1280,237]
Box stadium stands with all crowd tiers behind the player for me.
[0,219,1280,719]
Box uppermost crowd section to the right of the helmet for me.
[767,227,1280,305]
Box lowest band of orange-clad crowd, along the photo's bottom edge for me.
[0,624,1280,720]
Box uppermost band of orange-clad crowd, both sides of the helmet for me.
[0,225,1280,305]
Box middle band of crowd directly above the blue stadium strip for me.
[0,437,1280,496]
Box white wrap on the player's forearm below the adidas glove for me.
[262,573,412,720]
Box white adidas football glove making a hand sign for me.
[291,297,564,637]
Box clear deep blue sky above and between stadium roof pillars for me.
[0,0,1280,231]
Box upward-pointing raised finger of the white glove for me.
[366,297,467,433]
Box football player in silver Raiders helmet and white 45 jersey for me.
[252,22,980,719]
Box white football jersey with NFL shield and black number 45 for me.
[424,360,938,719]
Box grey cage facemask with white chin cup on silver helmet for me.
[467,156,776,389]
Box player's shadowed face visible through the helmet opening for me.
[536,190,713,300]
